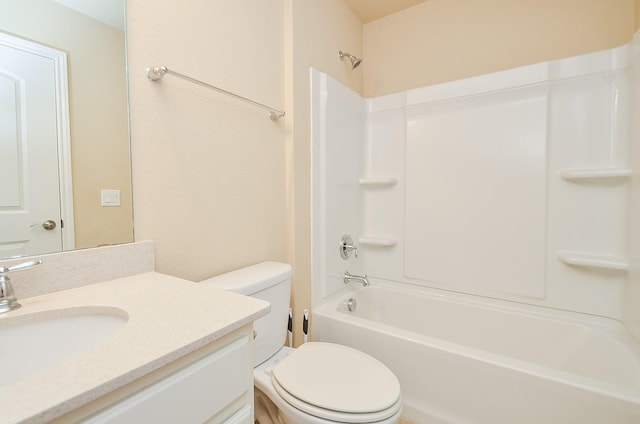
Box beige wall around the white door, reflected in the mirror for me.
[0,0,133,248]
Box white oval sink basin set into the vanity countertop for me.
[0,308,127,387]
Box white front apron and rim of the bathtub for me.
[314,294,640,424]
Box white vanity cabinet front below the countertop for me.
[56,325,253,424]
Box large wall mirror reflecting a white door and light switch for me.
[0,0,133,258]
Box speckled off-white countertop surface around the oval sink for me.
[0,272,269,423]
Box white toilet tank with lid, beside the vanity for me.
[200,262,291,366]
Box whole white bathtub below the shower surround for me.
[313,285,640,424]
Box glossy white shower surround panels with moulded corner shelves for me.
[311,32,638,319]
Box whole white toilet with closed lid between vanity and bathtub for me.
[200,262,402,424]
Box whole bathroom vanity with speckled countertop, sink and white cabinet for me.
[0,272,269,424]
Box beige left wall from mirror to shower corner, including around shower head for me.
[127,0,363,343]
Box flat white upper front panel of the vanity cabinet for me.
[85,337,253,424]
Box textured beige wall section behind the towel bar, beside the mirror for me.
[127,0,291,280]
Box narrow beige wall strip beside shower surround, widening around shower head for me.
[286,0,363,344]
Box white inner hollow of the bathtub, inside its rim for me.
[327,284,640,390]
